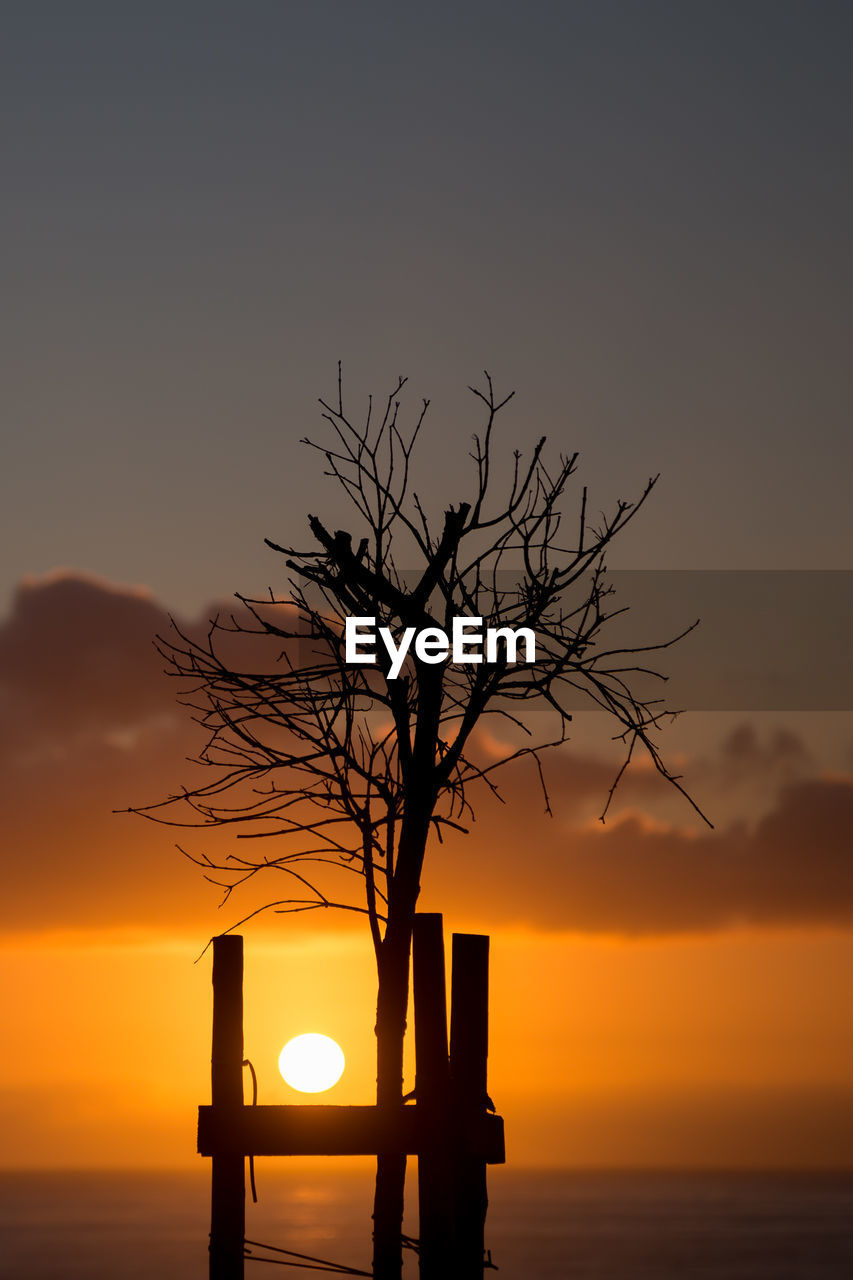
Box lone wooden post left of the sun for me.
[210,933,246,1280]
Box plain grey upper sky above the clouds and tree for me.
[0,0,853,609]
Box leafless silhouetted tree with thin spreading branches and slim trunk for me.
[136,369,692,1280]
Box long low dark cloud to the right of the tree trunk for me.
[427,760,853,934]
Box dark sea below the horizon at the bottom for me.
[0,1160,853,1280]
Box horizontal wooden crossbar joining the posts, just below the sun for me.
[199,1105,506,1165]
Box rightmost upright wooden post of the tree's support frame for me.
[450,933,489,1280]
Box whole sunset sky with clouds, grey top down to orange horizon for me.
[0,0,853,1167]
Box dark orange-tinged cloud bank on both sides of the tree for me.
[0,575,853,934]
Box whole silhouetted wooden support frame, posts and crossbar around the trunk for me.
[199,914,506,1280]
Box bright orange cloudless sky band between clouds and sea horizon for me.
[0,922,853,1166]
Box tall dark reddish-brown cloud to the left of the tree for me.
[0,573,224,928]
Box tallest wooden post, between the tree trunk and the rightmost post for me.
[412,913,453,1280]
